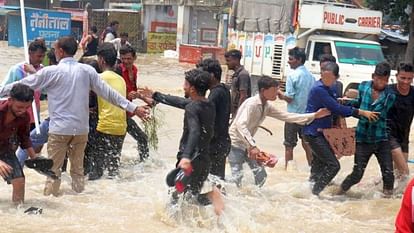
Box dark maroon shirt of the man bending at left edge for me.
[0,100,32,153]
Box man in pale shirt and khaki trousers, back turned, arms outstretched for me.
[0,36,148,196]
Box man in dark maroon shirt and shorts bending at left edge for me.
[0,84,36,205]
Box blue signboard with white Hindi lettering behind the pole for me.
[9,8,71,47]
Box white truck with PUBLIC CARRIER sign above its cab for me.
[228,0,394,91]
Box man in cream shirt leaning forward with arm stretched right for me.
[229,76,330,187]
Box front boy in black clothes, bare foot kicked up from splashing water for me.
[162,69,224,215]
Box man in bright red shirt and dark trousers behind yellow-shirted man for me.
[118,45,149,161]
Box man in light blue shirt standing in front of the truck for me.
[279,47,315,168]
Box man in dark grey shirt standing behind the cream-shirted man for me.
[224,49,252,118]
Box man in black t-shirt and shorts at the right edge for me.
[388,63,414,187]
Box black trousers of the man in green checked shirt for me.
[341,141,394,191]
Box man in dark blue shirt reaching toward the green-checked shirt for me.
[303,62,376,195]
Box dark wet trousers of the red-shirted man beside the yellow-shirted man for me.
[127,117,149,161]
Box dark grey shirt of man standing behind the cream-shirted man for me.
[231,66,252,117]
